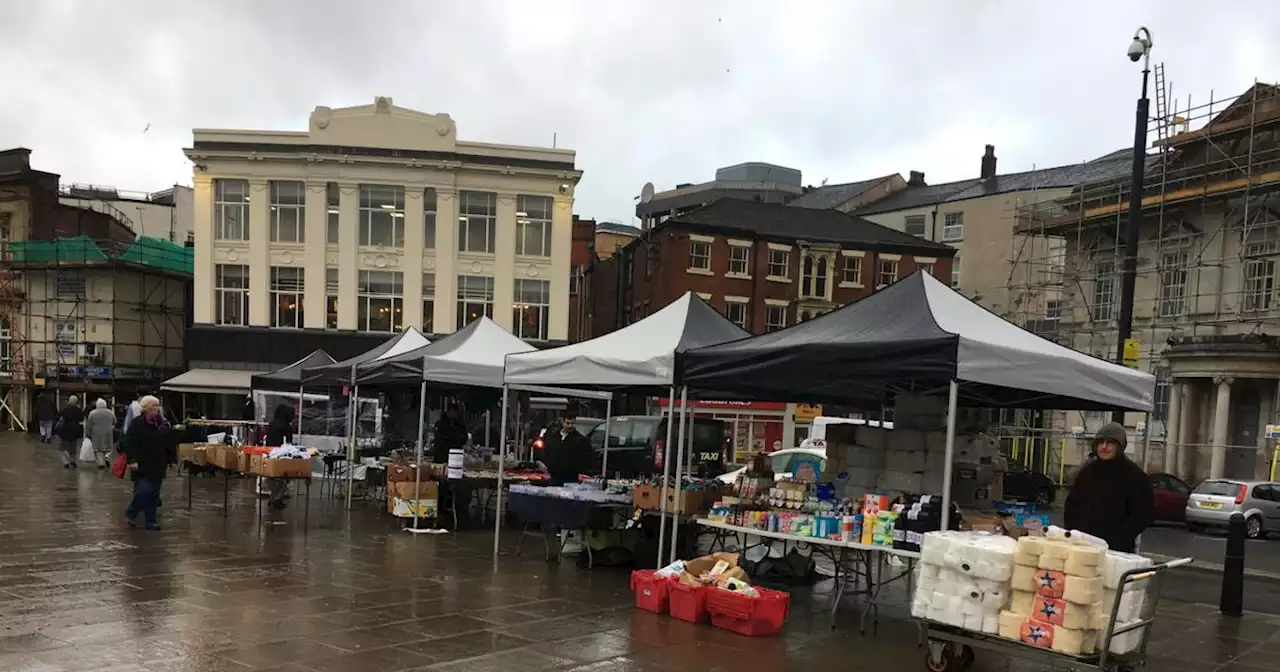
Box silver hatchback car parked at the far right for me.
[1187,479,1280,539]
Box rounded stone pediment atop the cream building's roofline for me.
[308,96,458,152]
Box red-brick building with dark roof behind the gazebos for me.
[588,198,955,335]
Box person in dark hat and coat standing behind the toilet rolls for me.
[1064,422,1156,553]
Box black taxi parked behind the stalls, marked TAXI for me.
[586,415,728,477]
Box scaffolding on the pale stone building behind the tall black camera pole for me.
[1001,73,1280,475]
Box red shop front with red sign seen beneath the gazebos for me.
[650,398,822,465]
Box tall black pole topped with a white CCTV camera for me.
[1111,28,1152,424]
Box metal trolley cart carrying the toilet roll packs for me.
[920,558,1192,672]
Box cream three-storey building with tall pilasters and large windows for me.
[186,97,582,355]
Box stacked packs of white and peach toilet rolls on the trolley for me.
[911,526,1152,655]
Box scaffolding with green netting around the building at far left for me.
[0,220,192,430]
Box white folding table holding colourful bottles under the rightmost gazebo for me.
[698,518,920,634]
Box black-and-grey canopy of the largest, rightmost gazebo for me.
[681,273,1156,411]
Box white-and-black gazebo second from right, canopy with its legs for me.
[494,292,750,558]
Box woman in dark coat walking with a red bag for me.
[120,394,174,530]
